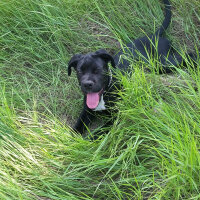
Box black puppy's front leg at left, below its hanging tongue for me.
[74,108,94,134]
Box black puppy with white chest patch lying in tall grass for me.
[68,0,198,134]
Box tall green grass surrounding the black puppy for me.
[0,0,200,200]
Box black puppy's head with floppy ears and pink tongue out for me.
[68,49,115,109]
